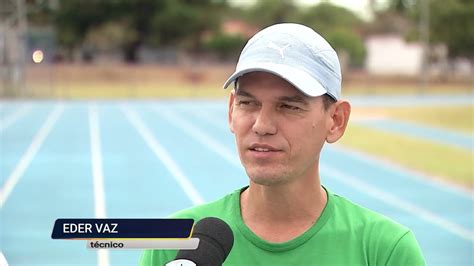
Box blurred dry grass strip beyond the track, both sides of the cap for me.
[12,63,473,99]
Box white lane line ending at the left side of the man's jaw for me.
[153,107,242,167]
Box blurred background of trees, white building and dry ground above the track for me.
[0,0,474,99]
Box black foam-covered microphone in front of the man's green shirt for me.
[166,217,234,266]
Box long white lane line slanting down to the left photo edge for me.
[0,104,64,209]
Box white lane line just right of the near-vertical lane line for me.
[121,106,204,205]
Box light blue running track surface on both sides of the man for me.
[0,100,474,265]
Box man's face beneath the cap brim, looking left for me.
[229,72,331,185]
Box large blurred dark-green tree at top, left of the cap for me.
[55,0,226,62]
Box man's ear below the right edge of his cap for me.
[326,100,351,143]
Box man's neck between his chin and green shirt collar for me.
[240,174,327,242]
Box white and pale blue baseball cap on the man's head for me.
[224,23,342,100]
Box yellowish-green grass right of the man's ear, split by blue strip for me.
[342,105,474,189]
